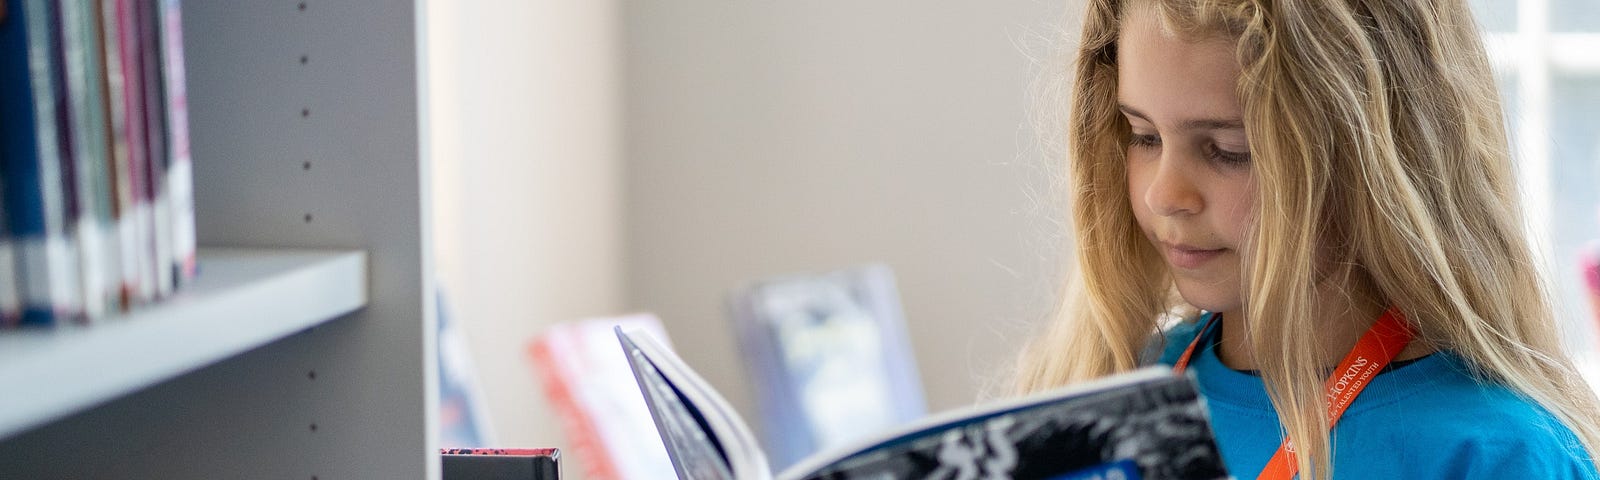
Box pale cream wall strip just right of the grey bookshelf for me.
[427,0,626,454]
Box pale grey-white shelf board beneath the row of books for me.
[0,248,368,438]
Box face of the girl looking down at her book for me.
[1117,11,1254,312]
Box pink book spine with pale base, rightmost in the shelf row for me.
[158,0,197,285]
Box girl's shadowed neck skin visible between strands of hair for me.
[1216,276,1434,370]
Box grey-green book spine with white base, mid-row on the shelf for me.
[61,0,117,322]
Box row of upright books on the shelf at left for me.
[0,0,197,326]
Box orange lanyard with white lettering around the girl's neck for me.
[1173,309,1416,480]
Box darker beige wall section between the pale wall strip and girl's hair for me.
[622,0,1062,428]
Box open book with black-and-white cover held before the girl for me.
[616,328,1227,480]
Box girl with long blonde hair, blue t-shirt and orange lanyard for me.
[1018,0,1600,478]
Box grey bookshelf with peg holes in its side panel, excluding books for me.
[0,0,438,480]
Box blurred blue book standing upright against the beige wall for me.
[730,264,926,469]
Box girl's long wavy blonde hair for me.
[1016,0,1600,478]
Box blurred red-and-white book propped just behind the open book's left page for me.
[528,314,677,480]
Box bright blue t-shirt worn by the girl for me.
[1160,314,1600,480]
